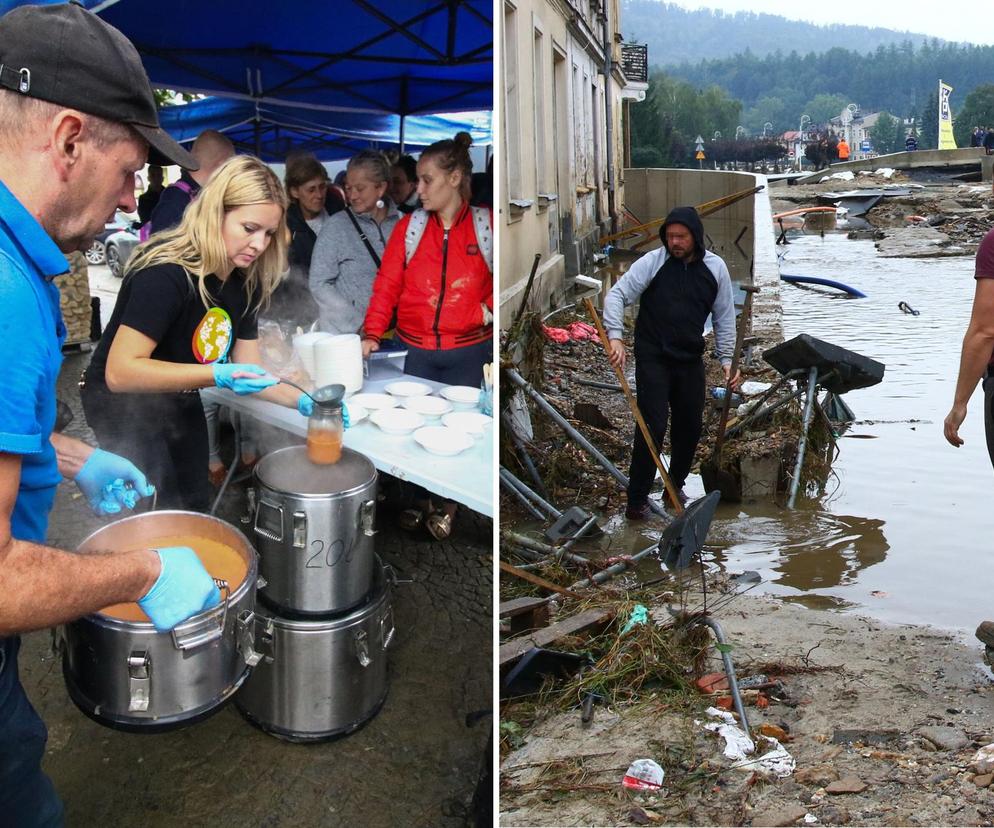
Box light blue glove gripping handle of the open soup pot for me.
[138,546,221,631]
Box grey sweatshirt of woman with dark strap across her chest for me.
[309,201,401,334]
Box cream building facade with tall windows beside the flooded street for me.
[496,0,647,326]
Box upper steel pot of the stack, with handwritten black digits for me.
[254,446,376,616]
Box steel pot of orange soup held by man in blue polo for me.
[56,511,259,732]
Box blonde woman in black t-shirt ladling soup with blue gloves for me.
[81,155,310,511]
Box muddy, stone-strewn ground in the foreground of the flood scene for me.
[500,576,994,826]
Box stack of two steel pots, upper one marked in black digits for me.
[235,446,394,741]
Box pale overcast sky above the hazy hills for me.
[671,0,994,45]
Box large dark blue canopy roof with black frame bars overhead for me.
[78,0,493,117]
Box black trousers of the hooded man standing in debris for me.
[628,353,705,506]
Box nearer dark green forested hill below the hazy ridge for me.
[666,40,994,128]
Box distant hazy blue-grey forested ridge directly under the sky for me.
[621,0,926,66]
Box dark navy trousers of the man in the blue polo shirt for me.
[0,637,63,828]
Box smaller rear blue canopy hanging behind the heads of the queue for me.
[160,98,493,163]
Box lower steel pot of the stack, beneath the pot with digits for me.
[235,561,394,742]
